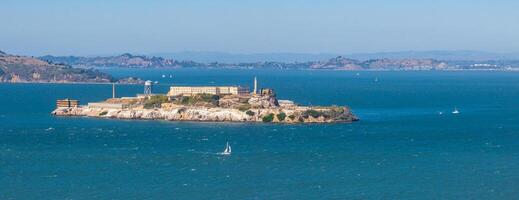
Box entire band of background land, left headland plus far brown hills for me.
[0,51,519,84]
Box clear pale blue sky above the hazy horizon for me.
[0,0,519,56]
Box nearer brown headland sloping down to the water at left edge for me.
[0,51,114,83]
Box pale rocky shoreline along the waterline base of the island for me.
[52,101,358,123]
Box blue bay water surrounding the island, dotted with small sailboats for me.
[0,70,519,199]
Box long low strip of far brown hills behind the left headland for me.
[40,53,519,70]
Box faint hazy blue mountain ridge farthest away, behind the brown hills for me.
[149,50,519,63]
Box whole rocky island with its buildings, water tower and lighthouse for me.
[52,78,358,123]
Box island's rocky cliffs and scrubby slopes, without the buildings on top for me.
[52,95,357,123]
